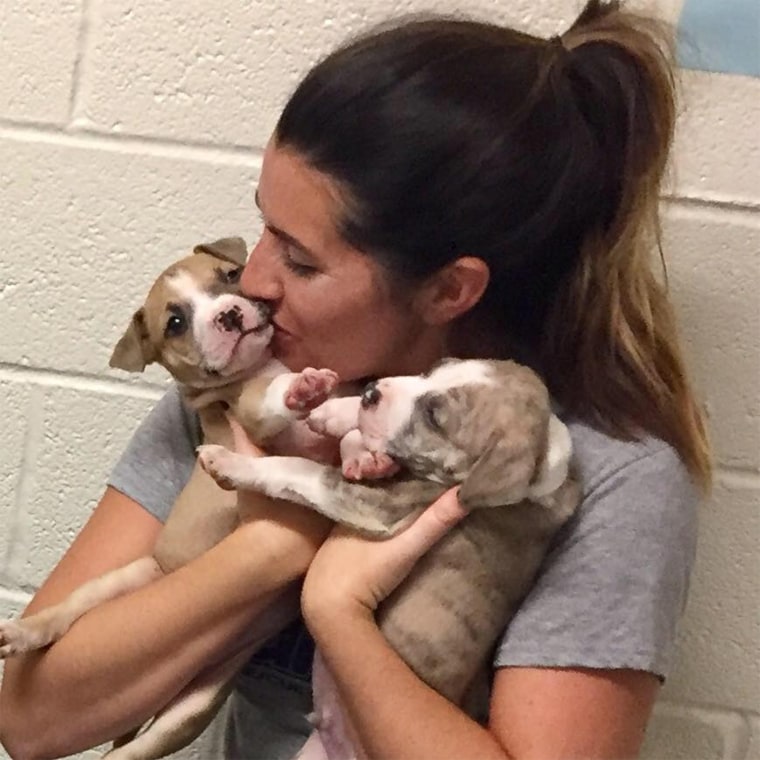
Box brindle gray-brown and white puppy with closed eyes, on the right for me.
[199,360,580,760]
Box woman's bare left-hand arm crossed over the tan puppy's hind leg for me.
[0,489,328,760]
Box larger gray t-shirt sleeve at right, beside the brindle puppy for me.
[494,444,698,679]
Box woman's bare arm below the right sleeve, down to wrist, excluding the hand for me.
[318,614,658,760]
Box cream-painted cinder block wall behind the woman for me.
[0,0,760,760]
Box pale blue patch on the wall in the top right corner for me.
[678,0,760,77]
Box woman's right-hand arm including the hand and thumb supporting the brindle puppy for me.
[303,493,658,760]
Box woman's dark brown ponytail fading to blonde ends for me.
[542,0,710,489]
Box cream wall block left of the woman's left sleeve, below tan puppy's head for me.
[3,387,159,588]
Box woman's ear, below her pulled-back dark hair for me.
[415,256,490,325]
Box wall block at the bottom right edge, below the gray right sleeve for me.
[641,704,748,760]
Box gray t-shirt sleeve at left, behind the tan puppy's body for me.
[108,385,200,522]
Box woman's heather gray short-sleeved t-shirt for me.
[109,387,698,760]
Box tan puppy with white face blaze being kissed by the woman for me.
[0,238,337,760]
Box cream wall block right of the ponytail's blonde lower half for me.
[664,203,760,470]
